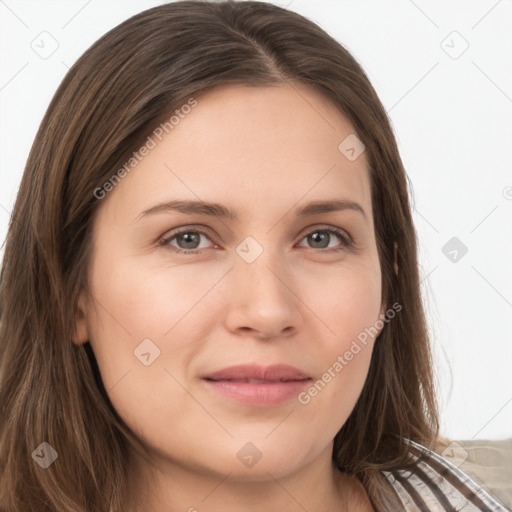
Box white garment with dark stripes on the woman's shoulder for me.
[382,440,512,512]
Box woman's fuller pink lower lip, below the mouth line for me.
[203,379,311,407]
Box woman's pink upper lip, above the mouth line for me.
[203,364,311,382]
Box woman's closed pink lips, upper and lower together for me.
[203,364,311,407]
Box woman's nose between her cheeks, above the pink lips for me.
[225,250,301,339]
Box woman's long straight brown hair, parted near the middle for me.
[0,1,438,512]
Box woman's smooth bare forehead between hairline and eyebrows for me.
[96,84,371,226]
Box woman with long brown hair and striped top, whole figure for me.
[0,1,505,512]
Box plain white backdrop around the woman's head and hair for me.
[0,0,512,439]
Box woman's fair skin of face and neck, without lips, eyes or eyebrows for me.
[74,85,386,512]
